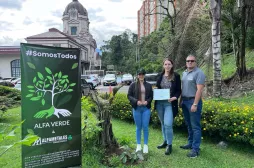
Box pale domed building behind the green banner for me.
[0,0,101,77]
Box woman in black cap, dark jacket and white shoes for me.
[128,70,153,153]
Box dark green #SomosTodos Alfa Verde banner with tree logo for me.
[21,44,81,168]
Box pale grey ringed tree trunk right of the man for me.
[210,0,222,97]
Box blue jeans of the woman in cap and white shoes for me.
[132,106,151,145]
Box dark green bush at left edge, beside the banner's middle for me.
[0,85,21,117]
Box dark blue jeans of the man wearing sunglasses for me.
[182,99,203,151]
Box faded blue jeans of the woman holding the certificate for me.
[156,100,173,145]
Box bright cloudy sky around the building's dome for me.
[0,0,142,47]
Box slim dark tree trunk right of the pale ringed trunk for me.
[238,0,247,80]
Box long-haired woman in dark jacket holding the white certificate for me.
[155,58,181,155]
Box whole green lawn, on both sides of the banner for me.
[0,108,254,168]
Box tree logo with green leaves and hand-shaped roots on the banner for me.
[26,62,78,118]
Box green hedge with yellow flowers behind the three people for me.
[110,93,254,146]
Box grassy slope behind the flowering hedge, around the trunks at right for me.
[200,50,254,98]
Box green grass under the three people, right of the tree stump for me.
[113,120,254,168]
